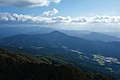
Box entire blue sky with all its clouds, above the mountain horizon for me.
[0,0,120,32]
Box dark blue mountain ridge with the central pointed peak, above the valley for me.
[0,31,120,58]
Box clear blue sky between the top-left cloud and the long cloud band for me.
[0,0,120,17]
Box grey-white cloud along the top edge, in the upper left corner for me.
[0,0,61,7]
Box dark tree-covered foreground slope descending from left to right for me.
[0,49,112,80]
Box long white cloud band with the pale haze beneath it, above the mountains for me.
[0,13,120,31]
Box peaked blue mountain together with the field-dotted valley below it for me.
[0,31,120,79]
